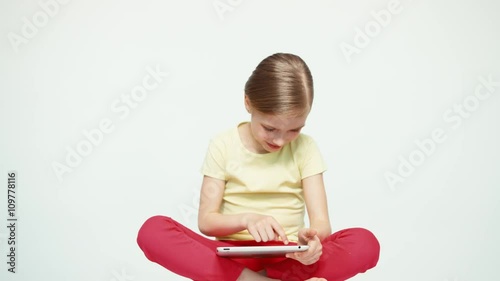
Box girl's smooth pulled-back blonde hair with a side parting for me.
[245,53,314,116]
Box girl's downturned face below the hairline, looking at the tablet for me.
[247,95,307,153]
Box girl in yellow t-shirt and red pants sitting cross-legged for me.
[137,53,380,281]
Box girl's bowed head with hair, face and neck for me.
[240,53,314,153]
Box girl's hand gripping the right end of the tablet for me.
[286,228,323,265]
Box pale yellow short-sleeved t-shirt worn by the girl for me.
[201,122,326,242]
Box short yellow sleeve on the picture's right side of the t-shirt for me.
[297,135,327,179]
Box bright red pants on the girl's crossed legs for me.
[137,216,380,281]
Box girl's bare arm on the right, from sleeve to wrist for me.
[302,174,332,241]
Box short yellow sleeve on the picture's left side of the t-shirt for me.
[201,139,226,180]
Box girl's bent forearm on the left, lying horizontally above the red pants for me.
[198,212,246,236]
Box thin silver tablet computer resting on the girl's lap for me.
[217,245,309,258]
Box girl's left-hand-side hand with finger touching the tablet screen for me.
[243,214,288,245]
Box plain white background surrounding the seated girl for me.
[0,0,500,281]
